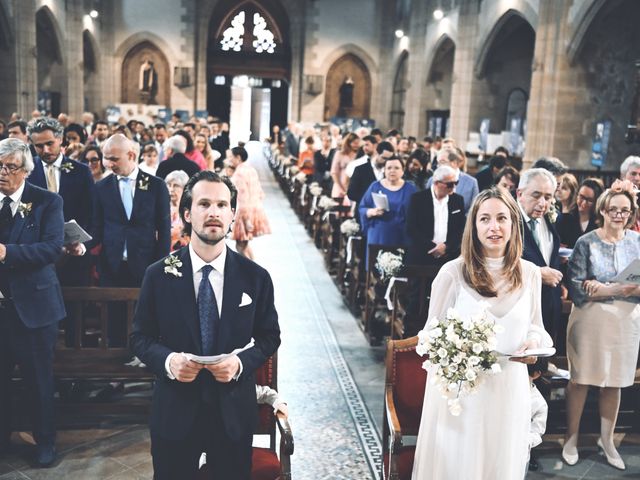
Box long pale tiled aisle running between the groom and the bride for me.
[252,155,384,480]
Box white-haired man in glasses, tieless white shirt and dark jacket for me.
[405,165,465,336]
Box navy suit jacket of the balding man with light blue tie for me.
[88,170,171,283]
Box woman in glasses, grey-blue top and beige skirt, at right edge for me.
[562,180,640,470]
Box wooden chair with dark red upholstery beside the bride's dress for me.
[381,337,427,480]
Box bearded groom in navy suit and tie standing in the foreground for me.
[130,171,280,480]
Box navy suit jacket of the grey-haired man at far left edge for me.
[0,182,66,328]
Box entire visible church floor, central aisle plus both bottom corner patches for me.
[0,151,640,480]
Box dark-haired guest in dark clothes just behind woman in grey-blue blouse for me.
[556,178,604,248]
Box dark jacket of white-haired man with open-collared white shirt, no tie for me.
[406,188,466,265]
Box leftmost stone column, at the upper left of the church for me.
[12,0,38,118]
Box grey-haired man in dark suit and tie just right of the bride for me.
[517,168,562,343]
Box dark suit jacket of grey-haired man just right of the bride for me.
[522,216,562,342]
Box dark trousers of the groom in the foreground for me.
[151,403,253,480]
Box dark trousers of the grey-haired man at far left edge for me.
[0,303,58,446]
